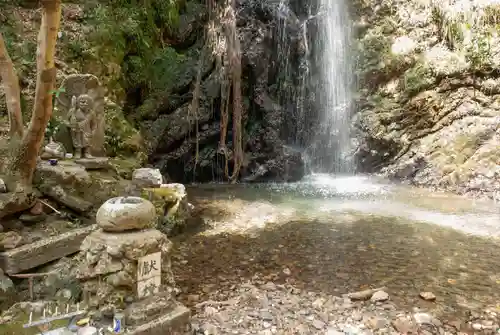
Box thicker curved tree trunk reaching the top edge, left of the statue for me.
[10,0,61,189]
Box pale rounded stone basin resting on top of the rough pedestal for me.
[96,197,156,232]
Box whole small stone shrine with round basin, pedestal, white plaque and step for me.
[73,197,190,334]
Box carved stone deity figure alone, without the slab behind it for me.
[68,94,96,159]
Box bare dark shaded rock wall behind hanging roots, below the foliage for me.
[135,0,304,182]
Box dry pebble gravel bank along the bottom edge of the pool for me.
[187,280,500,335]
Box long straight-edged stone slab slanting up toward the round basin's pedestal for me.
[0,225,97,275]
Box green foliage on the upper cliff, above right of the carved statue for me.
[82,0,182,90]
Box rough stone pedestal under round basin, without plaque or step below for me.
[73,229,174,310]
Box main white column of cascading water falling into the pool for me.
[306,0,354,174]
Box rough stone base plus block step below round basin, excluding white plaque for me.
[77,229,190,335]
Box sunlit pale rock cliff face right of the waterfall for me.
[354,0,500,199]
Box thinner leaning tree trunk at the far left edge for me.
[0,32,24,138]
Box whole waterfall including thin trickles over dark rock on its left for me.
[270,0,354,174]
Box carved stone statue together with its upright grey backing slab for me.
[54,74,105,158]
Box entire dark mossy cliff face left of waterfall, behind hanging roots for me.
[0,0,307,182]
